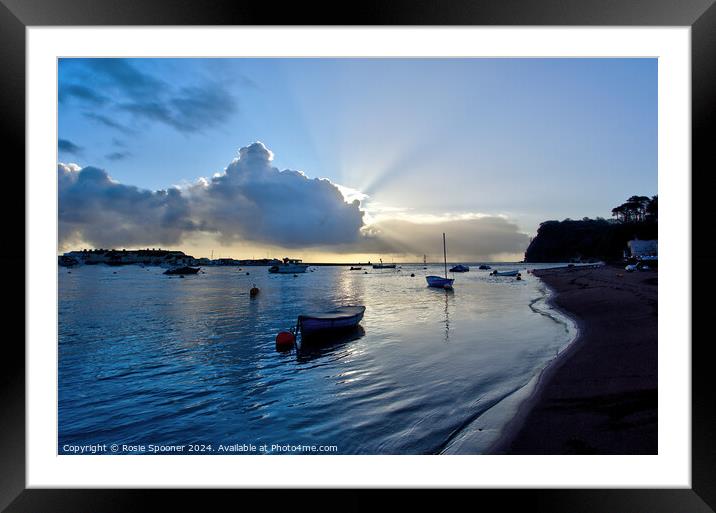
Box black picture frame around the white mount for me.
[0,0,716,513]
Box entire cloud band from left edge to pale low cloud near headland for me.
[58,142,529,261]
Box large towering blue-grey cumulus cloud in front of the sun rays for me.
[188,142,363,247]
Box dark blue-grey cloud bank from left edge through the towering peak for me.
[58,143,363,248]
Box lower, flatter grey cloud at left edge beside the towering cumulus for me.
[57,163,198,247]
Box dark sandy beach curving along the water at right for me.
[490,266,658,454]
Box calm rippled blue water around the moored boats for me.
[58,264,574,454]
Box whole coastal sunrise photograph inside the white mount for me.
[57,58,660,457]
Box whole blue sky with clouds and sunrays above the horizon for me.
[57,58,657,262]
